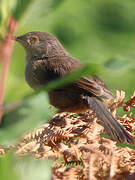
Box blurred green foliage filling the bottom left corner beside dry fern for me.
[0,153,52,180]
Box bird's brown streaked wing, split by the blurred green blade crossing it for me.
[34,57,113,99]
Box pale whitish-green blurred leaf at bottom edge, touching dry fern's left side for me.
[15,156,53,180]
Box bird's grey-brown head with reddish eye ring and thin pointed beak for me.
[13,32,68,61]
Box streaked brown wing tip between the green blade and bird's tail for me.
[73,76,114,99]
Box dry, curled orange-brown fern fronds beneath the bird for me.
[0,91,135,180]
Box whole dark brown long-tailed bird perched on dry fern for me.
[15,32,134,144]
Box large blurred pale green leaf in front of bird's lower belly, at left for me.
[0,92,53,144]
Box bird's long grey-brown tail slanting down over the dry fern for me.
[86,96,135,144]
